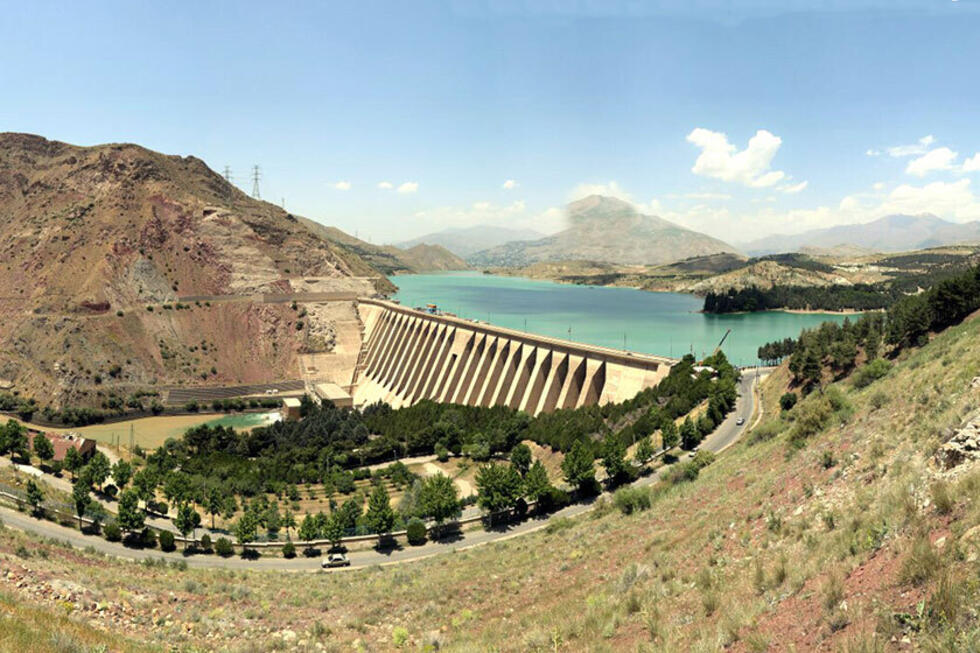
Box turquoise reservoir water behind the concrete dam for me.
[394,272,860,365]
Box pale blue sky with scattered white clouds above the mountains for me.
[0,0,980,244]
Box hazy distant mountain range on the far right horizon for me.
[742,213,980,254]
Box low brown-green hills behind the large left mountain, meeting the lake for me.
[299,218,469,275]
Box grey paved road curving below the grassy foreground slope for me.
[0,370,767,571]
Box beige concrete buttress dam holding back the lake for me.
[352,299,676,415]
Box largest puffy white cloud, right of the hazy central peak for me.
[687,127,786,188]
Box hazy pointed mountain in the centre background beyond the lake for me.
[467,195,735,267]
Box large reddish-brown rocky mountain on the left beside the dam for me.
[0,133,392,406]
